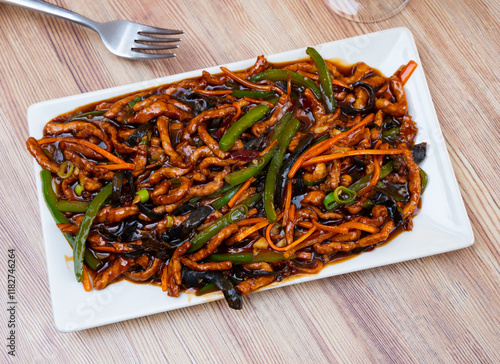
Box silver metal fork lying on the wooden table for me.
[0,0,183,59]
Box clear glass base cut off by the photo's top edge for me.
[324,0,410,23]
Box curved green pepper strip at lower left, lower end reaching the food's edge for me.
[73,183,113,282]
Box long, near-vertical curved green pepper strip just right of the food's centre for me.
[264,118,300,223]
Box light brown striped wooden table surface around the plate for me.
[0,0,500,363]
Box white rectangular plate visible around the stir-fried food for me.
[28,28,474,332]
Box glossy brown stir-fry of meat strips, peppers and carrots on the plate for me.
[27,48,427,309]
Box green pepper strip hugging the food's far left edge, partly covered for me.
[40,169,102,270]
